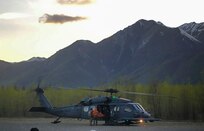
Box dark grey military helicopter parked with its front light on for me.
[29,85,171,125]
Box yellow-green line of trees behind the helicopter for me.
[0,82,204,121]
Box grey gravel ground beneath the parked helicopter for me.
[0,118,204,131]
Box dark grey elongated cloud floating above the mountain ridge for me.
[39,14,86,24]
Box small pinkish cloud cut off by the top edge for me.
[57,0,93,5]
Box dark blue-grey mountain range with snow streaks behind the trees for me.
[0,19,204,87]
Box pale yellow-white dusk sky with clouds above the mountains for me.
[0,0,204,62]
